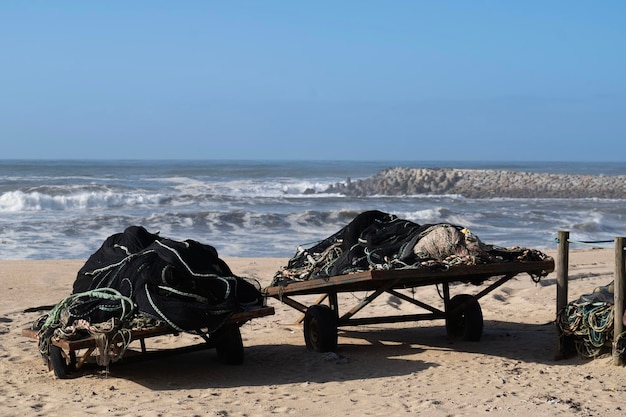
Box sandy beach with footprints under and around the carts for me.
[0,249,626,417]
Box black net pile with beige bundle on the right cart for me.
[272,210,548,285]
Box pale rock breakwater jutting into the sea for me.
[325,167,626,199]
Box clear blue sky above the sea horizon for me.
[0,0,626,161]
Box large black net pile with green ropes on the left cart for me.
[33,226,264,362]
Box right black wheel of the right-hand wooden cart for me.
[446,294,483,342]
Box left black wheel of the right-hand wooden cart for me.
[304,304,337,352]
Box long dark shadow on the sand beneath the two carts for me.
[77,321,582,390]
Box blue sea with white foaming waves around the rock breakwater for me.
[0,160,626,259]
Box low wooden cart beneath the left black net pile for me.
[22,306,274,378]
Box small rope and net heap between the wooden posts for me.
[557,282,626,358]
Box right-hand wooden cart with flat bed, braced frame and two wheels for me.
[263,257,554,352]
